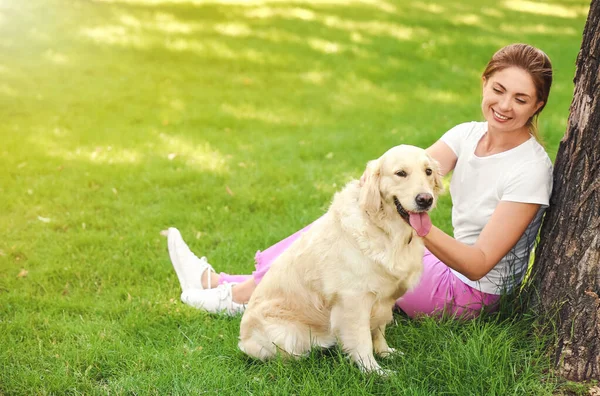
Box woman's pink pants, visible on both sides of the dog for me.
[219,225,500,319]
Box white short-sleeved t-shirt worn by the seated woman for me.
[441,122,552,294]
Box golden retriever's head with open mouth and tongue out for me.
[359,145,443,236]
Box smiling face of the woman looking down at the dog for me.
[481,67,543,131]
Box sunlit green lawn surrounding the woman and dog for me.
[0,0,588,395]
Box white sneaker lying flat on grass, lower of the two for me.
[181,282,246,315]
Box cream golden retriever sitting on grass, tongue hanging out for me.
[239,145,442,373]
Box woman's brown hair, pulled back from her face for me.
[482,44,552,143]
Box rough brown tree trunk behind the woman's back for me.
[533,0,600,381]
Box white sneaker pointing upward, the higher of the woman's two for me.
[167,227,215,291]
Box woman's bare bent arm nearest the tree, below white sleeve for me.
[423,201,541,281]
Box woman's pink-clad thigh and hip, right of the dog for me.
[396,249,500,319]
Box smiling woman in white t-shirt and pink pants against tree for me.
[168,44,552,318]
